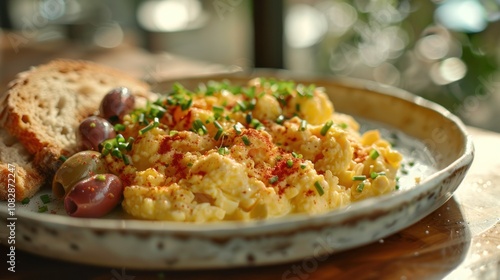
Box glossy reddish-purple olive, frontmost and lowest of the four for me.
[64,174,123,218]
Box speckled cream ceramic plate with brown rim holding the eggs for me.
[0,71,473,269]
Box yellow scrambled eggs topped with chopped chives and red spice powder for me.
[105,78,402,222]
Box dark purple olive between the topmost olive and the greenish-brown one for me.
[76,116,116,151]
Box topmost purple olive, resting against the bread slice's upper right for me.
[99,87,135,123]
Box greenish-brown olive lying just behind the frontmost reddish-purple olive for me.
[52,151,108,198]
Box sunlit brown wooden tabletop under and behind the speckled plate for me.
[0,40,500,280]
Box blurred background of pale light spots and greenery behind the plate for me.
[0,0,500,132]
